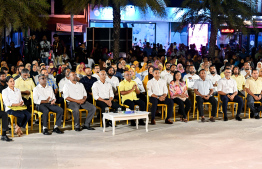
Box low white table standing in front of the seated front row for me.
[103,111,149,135]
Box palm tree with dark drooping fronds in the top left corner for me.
[0,0,50,56]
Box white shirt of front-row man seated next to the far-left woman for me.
[33,84,56,104]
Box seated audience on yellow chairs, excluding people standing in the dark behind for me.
[0,41,262,141]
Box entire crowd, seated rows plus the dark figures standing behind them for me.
[0,34,262,141]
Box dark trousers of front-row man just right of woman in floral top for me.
[196,96,217,117]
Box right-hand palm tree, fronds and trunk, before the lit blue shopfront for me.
[178,0,256,57]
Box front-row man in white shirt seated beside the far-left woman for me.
[33,75,63,135]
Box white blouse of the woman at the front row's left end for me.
[2,87,23,111]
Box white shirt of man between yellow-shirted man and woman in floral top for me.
[147,78,168,97]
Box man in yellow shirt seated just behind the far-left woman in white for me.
[15,69,35,112]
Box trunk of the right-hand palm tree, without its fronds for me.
[208,18,218,58]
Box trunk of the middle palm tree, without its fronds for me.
[113,3,121,60]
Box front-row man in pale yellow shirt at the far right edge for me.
[245,69,262,119]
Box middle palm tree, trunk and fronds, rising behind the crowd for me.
[64,0,168,60]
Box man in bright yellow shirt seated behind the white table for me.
[119,71,146,126]
